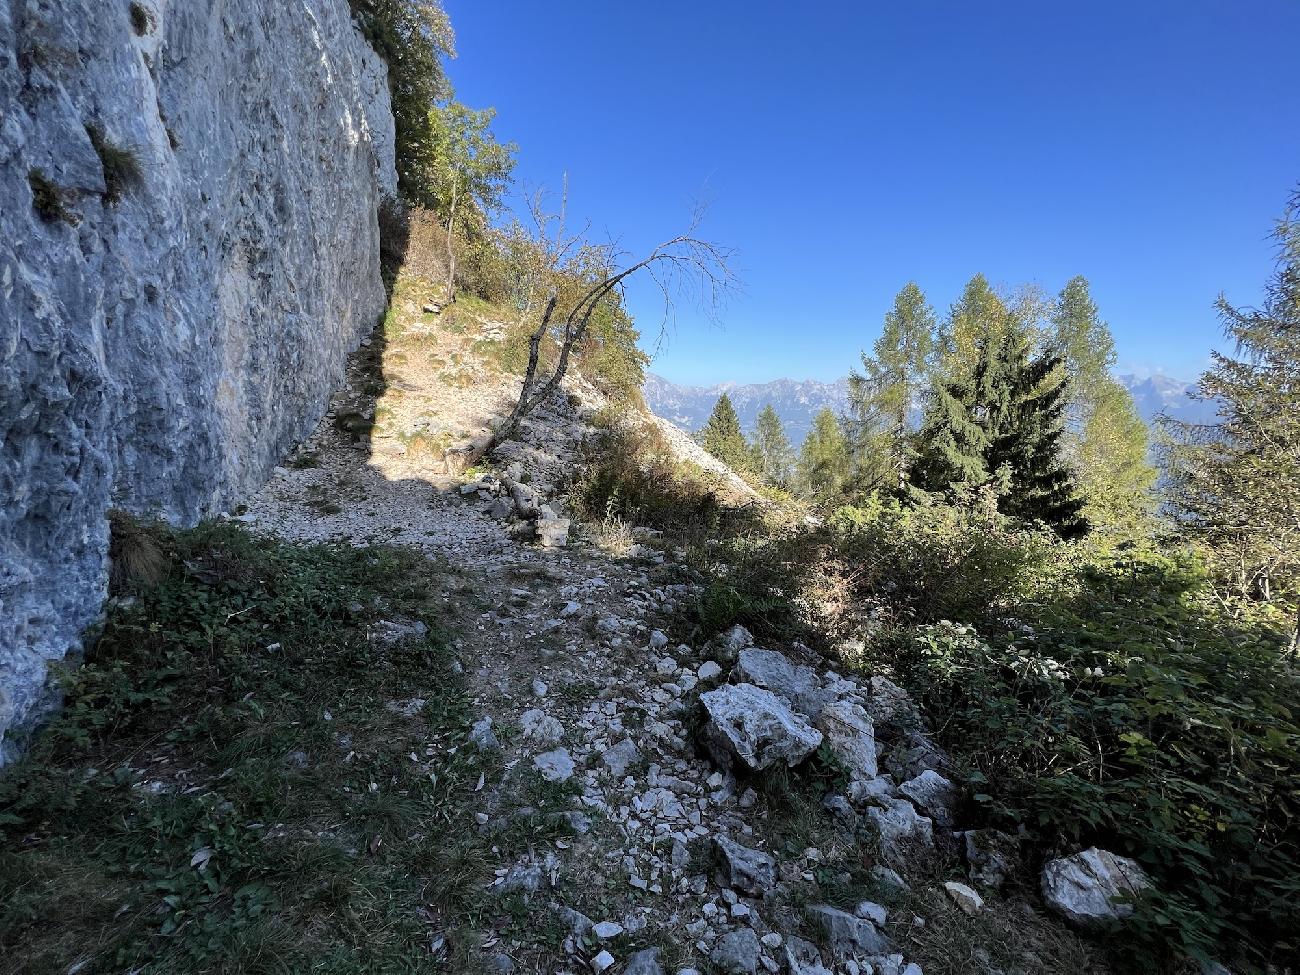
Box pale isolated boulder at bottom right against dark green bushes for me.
[1043,846,1151,931]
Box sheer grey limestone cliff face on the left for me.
[0,0,397,762]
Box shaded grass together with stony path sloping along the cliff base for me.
[0,263,1118,975]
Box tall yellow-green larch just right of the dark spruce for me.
[1052,277,1157,534]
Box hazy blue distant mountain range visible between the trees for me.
[644,373,1214,446]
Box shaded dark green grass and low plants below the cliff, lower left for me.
[0,525,482,972]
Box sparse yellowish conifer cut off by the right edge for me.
[1165,191,1300,650]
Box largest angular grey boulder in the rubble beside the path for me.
[699,684,822,771]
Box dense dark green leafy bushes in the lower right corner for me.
[892,546,1300,965]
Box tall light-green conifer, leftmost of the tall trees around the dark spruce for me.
[849,282,935,491]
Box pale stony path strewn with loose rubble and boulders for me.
[235,301,1140,975]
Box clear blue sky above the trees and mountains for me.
[446,0,1300,384]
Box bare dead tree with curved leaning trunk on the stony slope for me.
[482,201,736,454]
